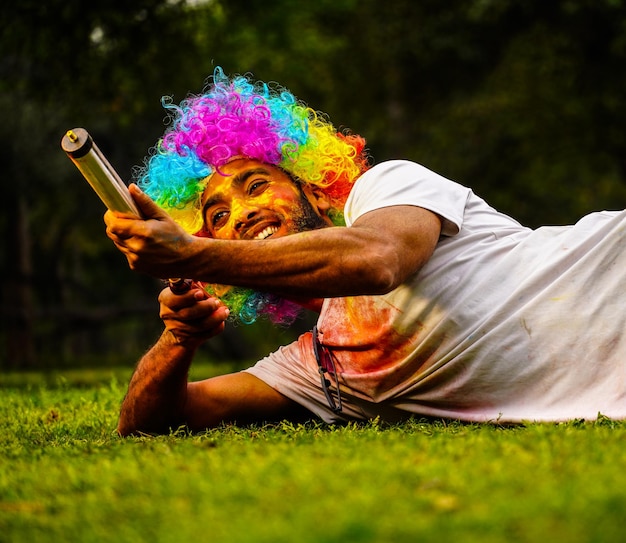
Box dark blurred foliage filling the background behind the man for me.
[0,0,626,367]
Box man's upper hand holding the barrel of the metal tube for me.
[104,184,194,278]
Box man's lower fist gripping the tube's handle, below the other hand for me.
[159,287,229,348]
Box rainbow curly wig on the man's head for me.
[134,67,369,322]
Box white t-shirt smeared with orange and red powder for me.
[246,161,626,422]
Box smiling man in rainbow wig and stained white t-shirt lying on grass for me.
[105,69,626,435]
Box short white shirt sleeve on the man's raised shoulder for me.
[344,160,471,236]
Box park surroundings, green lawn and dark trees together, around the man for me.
[0,0,626,543]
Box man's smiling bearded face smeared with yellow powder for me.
[202,158,332,240]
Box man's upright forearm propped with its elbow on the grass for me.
[117,331,196,436]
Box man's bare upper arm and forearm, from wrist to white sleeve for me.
[183,206,441,298]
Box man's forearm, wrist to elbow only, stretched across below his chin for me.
[188,228,390,298]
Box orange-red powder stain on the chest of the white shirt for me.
[318,278,449,401]
